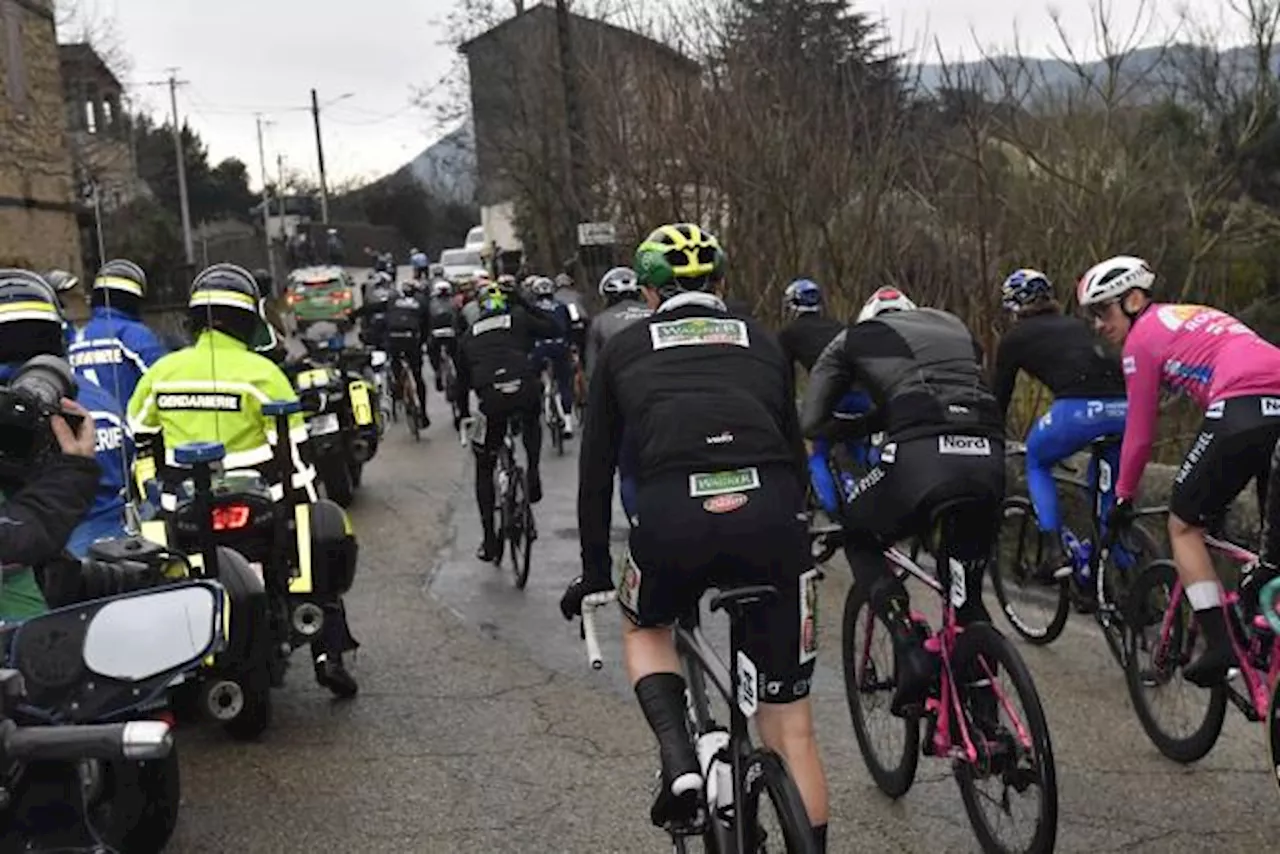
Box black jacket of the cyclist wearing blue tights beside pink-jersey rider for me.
[991,312,1125,414]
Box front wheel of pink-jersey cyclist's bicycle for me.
[1125,561,1226,763]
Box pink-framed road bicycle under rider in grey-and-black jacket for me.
[841,502,1057,854]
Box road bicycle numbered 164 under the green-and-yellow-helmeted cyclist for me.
[582,588,817,854]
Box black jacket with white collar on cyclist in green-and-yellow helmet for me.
[577,293,808,577]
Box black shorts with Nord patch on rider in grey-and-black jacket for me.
[844,435,1005,560]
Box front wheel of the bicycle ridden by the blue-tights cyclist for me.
[991,495,1071,647]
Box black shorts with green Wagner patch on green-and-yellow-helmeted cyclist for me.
[618,465,818,703]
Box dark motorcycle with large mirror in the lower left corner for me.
[0,581,227,854]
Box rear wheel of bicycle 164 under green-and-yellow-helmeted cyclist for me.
[741,749,818,854]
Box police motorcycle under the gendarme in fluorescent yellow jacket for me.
[143,427,357,740]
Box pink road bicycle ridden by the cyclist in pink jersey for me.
[1125,517,1280,767]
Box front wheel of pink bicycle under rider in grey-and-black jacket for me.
[840,584,920,798]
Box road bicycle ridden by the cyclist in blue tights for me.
[992,437,1165,667]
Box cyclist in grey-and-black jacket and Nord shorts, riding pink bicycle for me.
[800,288,1005,717]
